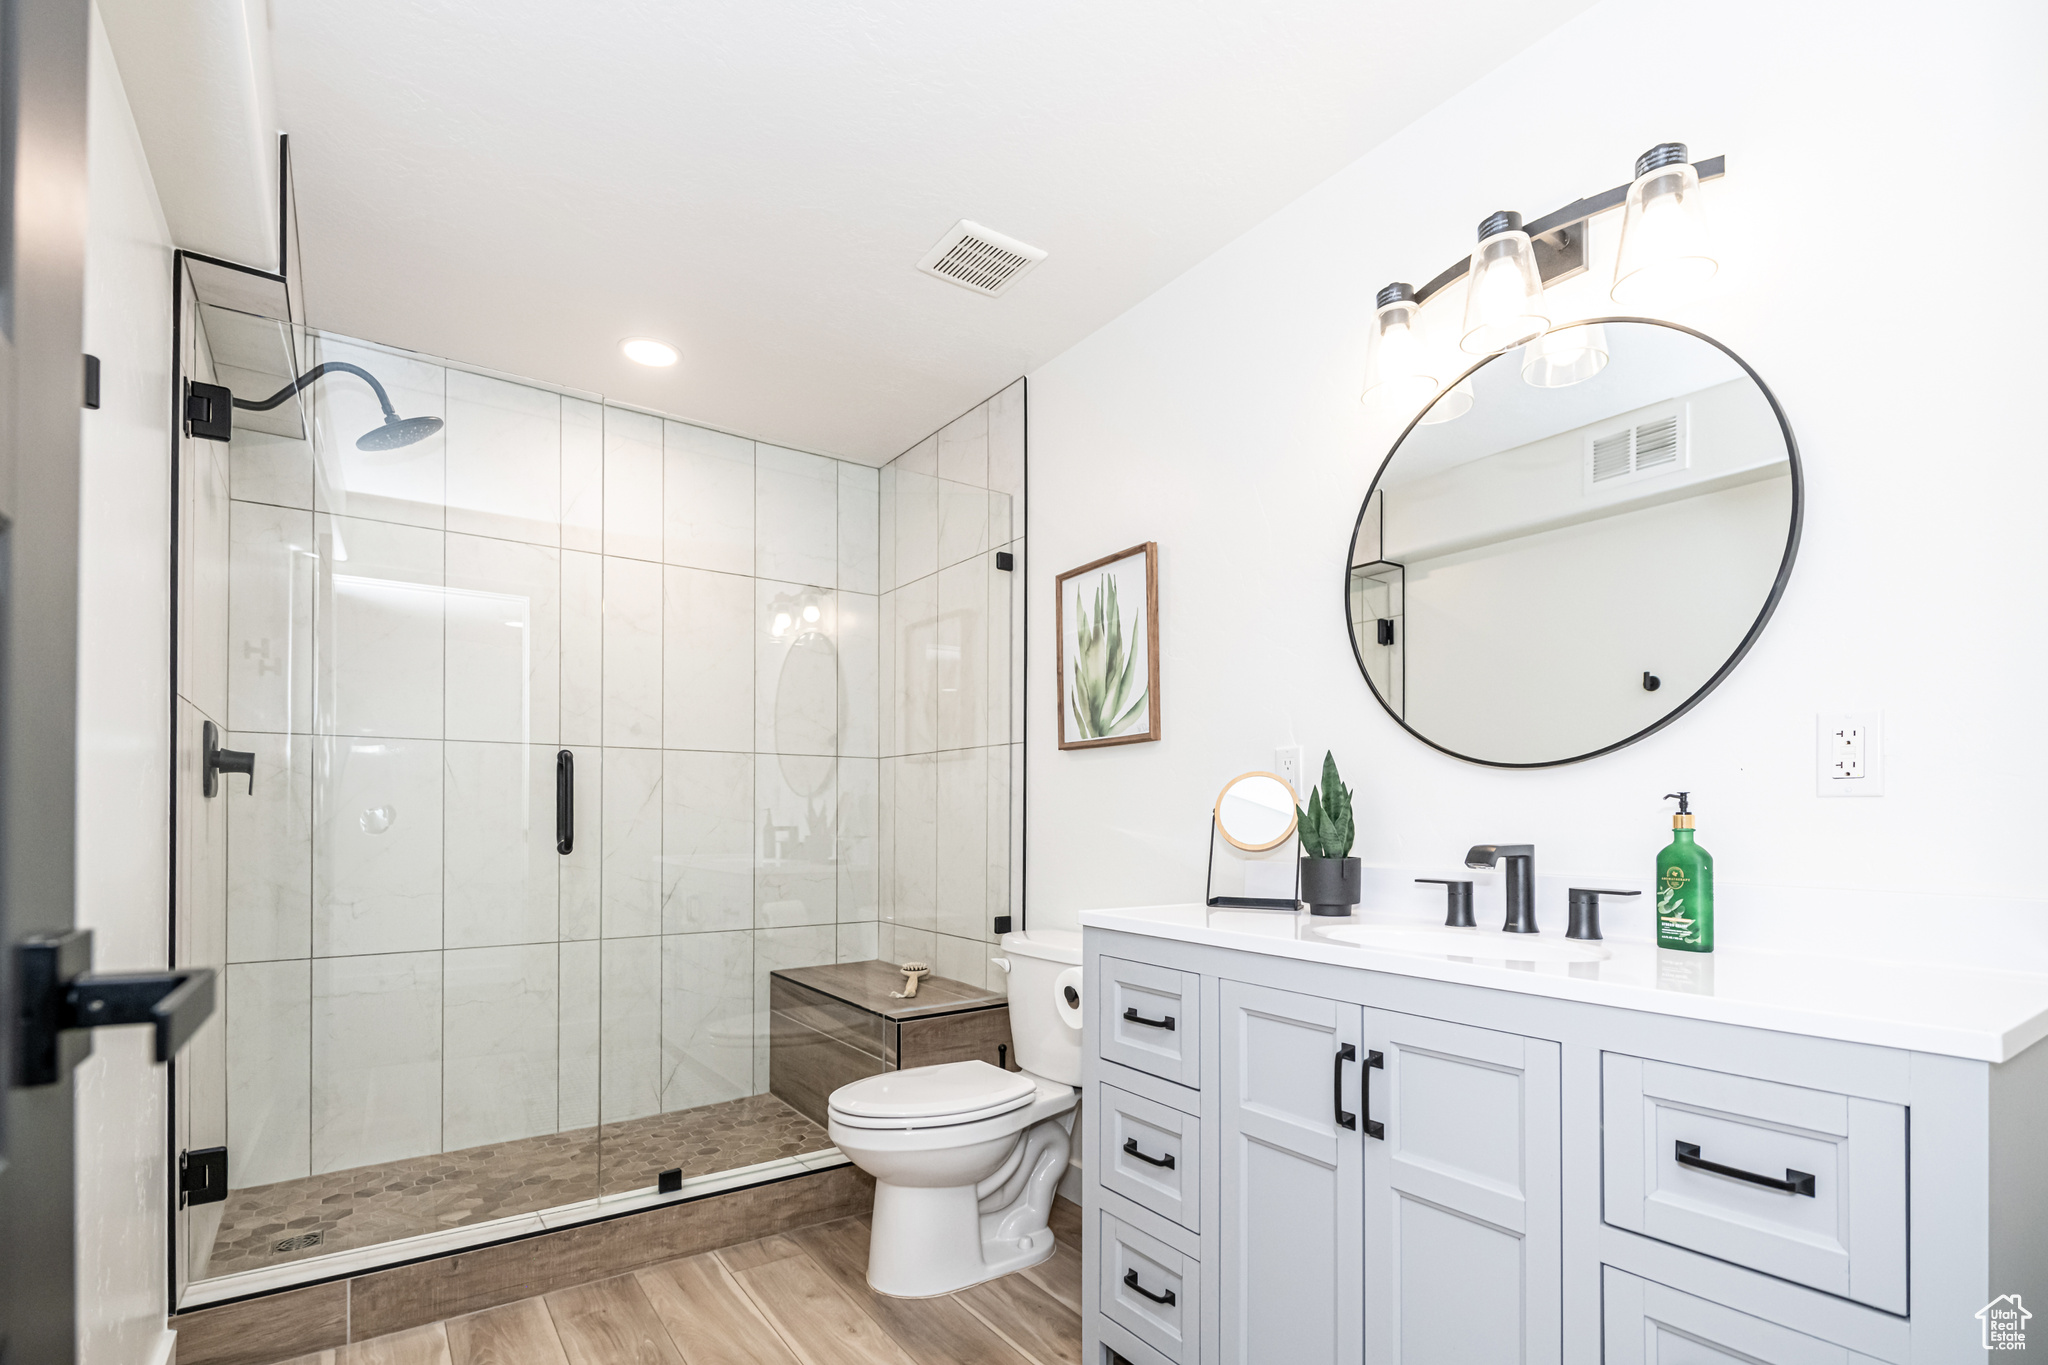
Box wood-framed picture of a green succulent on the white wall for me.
[1053,540,1159,749]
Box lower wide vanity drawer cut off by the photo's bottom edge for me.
[1602,1265,1878,1365]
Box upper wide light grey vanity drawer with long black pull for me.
[1599,1052,1907,1314]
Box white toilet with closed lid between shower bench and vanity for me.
[827,929,1081,1300]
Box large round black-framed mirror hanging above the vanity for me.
[1346,317,1802,767]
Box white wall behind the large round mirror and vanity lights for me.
[1028,0,2048,966]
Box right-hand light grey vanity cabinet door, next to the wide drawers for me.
[1360,1009,1563,1365]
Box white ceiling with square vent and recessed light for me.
[270,0,1591,465]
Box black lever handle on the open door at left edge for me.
[14,929,213,1087]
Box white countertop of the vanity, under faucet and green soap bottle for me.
[1081,905,2048,1062]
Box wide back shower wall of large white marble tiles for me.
[199,338,883,1187]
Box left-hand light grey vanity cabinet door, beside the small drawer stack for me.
[1219,980,1359,1365]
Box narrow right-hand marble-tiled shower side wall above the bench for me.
[881,381,1024,990]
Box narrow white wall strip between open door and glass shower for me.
[76,10,172,1365]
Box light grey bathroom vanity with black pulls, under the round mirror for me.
[1081,907,2048,1365]
